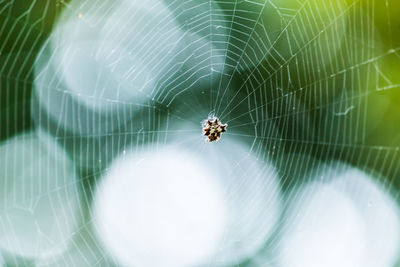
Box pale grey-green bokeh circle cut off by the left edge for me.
[0,132,80,259]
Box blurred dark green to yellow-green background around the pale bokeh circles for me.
[0,0,400,264]
